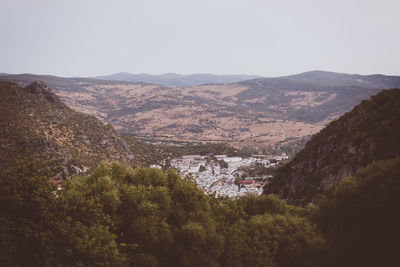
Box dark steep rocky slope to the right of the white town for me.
[264,89,400,204]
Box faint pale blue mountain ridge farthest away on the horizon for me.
[95,72,261,86]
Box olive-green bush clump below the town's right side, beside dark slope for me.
[211,195,326,266]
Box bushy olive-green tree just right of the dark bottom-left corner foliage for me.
[56,163,128,266]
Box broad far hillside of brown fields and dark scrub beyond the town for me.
[0,71,400,153]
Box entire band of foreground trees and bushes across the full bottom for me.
[0,158,400,266]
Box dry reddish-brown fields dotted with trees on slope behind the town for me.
[50,84,335,148]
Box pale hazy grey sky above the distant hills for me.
[0,0,400,76]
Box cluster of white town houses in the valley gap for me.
[159,154,287,198]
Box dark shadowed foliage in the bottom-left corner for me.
[0,160,57,266]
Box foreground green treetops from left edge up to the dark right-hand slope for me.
[0,162,324,266]
